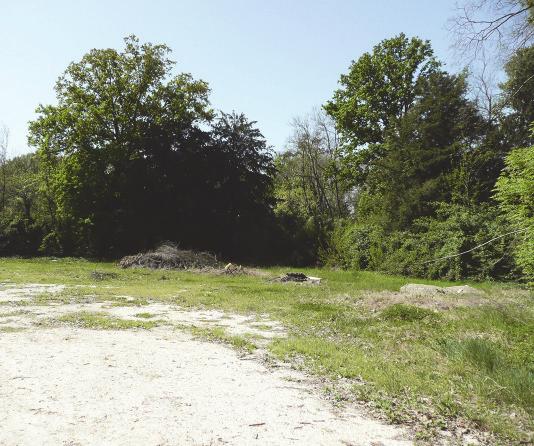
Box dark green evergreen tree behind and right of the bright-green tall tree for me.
[362,72,484,229]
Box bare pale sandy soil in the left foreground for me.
[0,286,412,446]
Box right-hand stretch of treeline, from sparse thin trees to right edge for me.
[276,34,534,280]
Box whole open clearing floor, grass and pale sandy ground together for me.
[0,259,534,446]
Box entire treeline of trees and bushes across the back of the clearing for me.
[0,34,534,279]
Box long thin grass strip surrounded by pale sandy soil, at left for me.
[49,311,158,330]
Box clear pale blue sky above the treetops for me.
[0,0,455,156]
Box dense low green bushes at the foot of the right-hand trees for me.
[325,203,518,280]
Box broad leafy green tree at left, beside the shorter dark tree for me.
[29,36,212,255]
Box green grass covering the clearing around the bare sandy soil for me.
[0,259,534,444]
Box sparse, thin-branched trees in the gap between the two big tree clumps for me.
[275,111,348,263]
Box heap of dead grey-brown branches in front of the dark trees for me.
[119,242,221,270]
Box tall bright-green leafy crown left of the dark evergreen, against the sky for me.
[325,34,440,182]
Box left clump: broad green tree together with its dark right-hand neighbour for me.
[30,36,272,256]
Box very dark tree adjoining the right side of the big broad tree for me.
[191,112,274,261]
